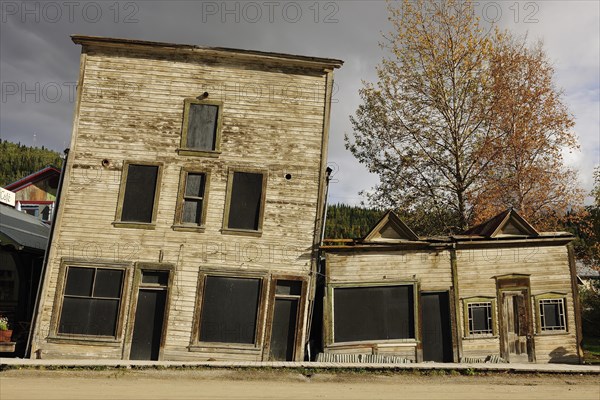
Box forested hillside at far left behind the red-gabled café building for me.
[0,139,62,186]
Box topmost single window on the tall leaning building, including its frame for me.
[179,99,222,156]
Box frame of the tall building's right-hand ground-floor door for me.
[262,275,308,361]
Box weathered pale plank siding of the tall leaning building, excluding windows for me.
[33,41,338,360]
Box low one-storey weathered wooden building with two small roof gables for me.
[319,210,582,363]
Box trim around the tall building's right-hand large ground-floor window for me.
[188,268,269,353]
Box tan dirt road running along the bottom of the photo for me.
[0,369,600,400]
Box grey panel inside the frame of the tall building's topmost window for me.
[186,103,219,151]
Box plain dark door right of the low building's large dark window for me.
[421,292,452,362]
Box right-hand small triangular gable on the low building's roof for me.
[462,208,540,238]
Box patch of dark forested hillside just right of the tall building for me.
[325,204,384,239]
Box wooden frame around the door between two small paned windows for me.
[495,274,536,362]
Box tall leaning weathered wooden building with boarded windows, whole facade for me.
[31,36,342,360]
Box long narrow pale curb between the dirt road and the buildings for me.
[0,358,600,375]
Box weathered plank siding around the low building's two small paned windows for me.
[457,246,577,362]
